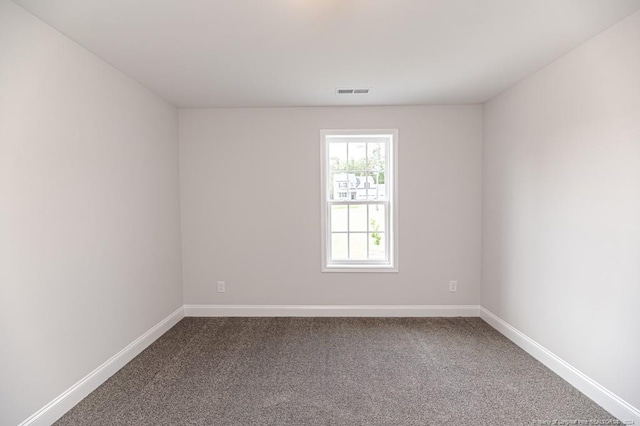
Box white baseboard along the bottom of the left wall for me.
[19,306,184,426]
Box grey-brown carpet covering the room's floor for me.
[56,318,615,426]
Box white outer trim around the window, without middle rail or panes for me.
[320,129,398,272]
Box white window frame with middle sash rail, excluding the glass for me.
[320,129,398,272]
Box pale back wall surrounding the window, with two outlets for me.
[180,106,482,305]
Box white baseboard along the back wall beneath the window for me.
[184,305,479,317]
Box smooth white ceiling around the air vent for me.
[15,0,640,107]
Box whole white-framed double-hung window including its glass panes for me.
[321,130,398,272]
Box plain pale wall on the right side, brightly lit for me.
[482,12,640,407]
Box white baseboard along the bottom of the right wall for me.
[479,306,640,425]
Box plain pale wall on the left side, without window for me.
[0,0,182,425]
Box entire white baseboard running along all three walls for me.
[19,305,640,426]
